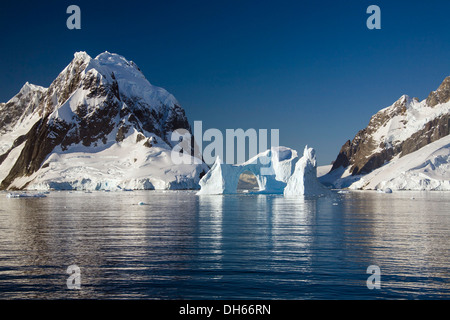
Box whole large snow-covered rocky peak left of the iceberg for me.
[0,52,208,189]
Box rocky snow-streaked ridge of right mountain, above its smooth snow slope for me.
[320,77,450,189]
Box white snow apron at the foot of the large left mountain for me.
[22,131,208,191]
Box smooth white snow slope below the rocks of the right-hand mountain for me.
[350,136,450,191]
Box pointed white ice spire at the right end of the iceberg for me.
[284,146,330,196]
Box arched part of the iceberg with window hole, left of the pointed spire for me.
[197,147,299,195]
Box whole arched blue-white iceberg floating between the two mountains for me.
[197,147,328,196]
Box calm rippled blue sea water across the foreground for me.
[0,191,450,300]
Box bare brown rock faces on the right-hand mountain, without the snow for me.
[331,77,450,175]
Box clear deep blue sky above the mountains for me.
[0,0,450,164]
